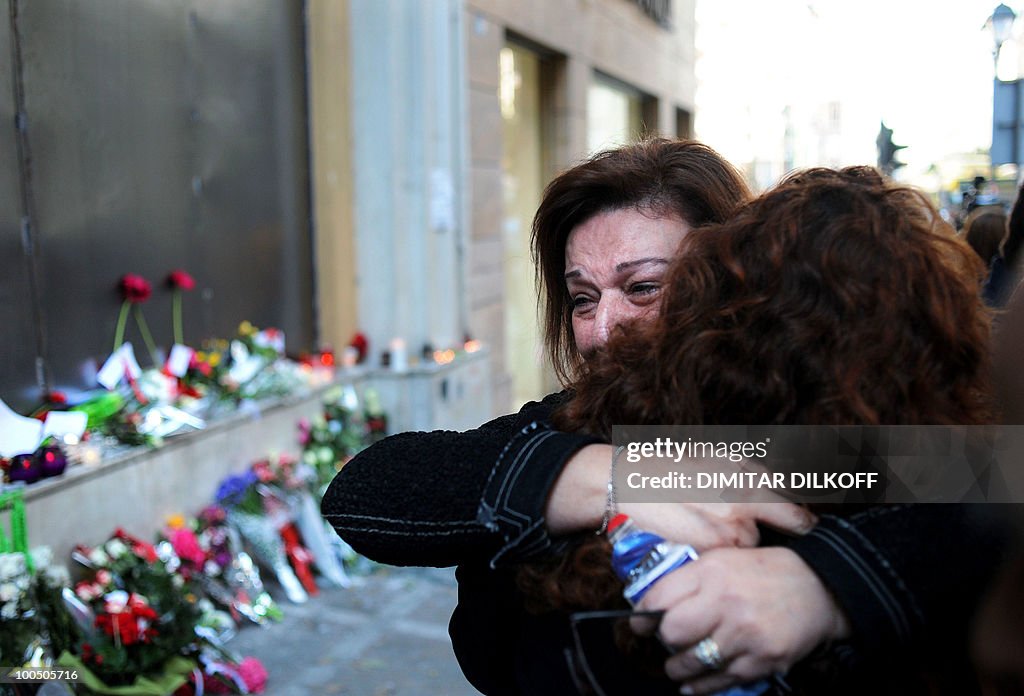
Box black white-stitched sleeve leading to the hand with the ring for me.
[787,504,1010,658]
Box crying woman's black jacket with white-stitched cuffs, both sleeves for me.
[322,393,1007,694]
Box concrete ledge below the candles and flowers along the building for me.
[8,350,490,560]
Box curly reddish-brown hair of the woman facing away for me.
[521,168,992,608]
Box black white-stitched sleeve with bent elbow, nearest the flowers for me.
[321,394,597,566]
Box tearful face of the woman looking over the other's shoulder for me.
[565,208,690,359]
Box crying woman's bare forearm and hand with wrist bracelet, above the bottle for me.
[545,444,816,552]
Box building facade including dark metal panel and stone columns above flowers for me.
[0,0,695,426]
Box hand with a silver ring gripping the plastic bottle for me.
[633,547,850,694]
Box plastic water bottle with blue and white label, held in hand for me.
[607,514,772,696]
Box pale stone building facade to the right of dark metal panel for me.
[323,0,695,414]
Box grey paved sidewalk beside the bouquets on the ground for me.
[227,566,478,696]
